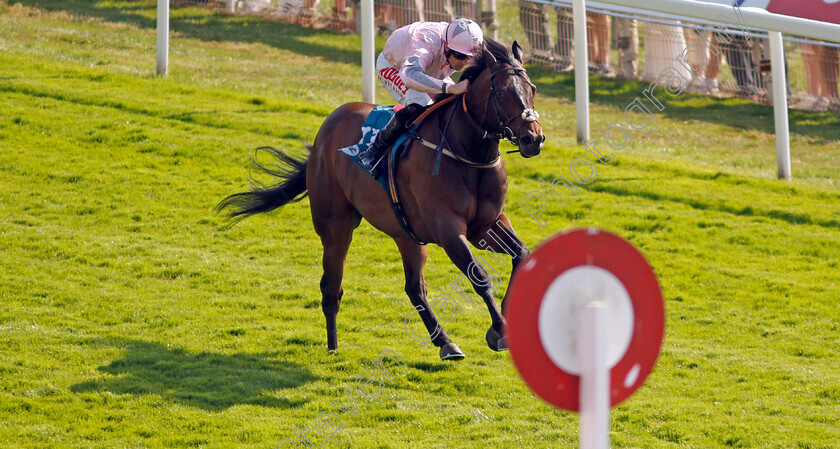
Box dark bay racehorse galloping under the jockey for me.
[216,39,545,360]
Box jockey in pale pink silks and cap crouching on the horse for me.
[359,19,484,170]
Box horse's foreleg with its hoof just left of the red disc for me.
[439,233,507,351]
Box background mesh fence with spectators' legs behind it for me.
[173,0,840,111]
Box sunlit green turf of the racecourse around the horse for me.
[0,0,840,449]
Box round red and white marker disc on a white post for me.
[506,228,665,449]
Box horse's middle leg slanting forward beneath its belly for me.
[394,239,464,360]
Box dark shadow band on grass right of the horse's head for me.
[528,66,840,141]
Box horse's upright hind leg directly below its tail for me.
[310,195,361,351]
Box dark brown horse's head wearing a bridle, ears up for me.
[464,39,545,157]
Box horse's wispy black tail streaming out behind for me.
[216,145,311,224]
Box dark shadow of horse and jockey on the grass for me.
[70,340,317,411]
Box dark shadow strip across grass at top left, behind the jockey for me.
[16,0,362,65]
